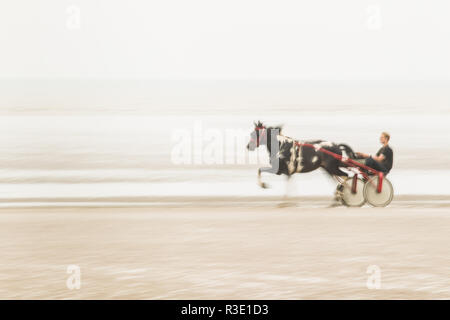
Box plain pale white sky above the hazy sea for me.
[0,0,450,80]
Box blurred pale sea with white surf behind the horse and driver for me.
[0,79,450,207]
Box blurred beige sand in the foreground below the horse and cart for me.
[0,202,450,299]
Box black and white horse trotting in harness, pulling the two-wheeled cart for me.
[247,122,355,188]
